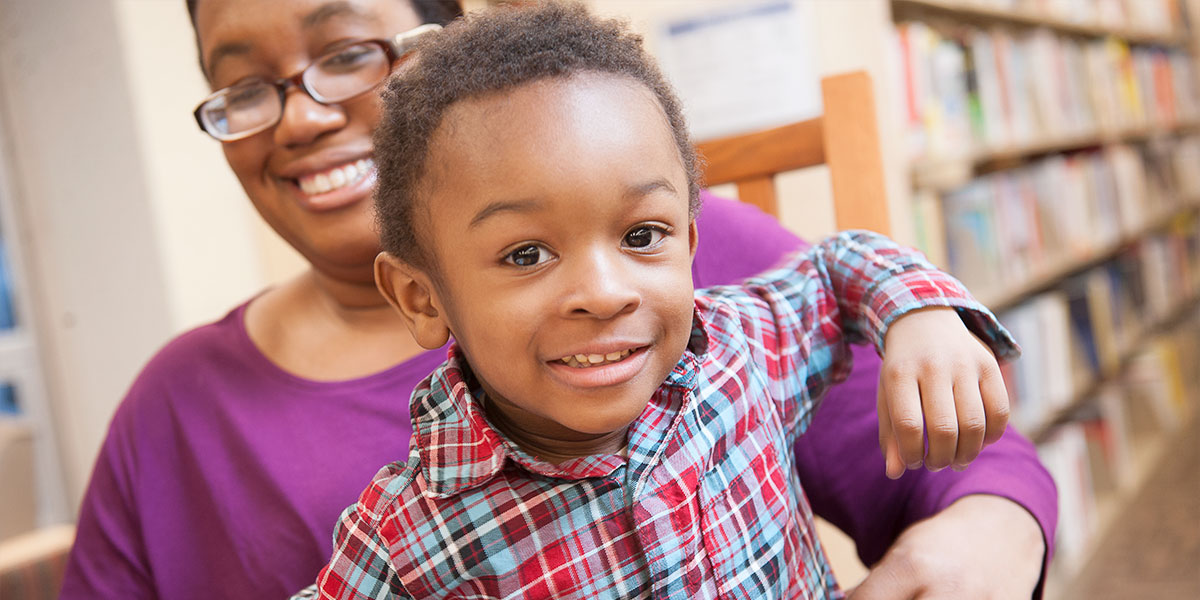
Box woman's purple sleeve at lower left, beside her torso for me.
[59,398,157,600]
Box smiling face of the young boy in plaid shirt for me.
[382,73,696,460]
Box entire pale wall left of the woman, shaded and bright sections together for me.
[0,0,294,514]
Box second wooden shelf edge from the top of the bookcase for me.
[911,120,1200,191]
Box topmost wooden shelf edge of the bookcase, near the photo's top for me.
[892,0,1187,47]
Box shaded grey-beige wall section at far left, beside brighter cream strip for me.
[0,0,169,511]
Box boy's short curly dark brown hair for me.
[374,1,700,268]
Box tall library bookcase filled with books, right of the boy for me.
[890,0,1200,598]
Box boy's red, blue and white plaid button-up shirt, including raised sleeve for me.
[290,232,1018,600]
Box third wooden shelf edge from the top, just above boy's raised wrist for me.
[977,198,1200,312]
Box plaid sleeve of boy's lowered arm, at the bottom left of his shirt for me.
[312,496,408,600]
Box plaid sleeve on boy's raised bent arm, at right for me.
[713,230,1019,439]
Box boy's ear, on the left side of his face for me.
[374,252,450,349]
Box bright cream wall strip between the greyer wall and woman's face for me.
[112,0,271,330]
